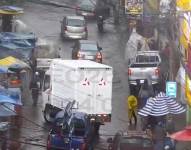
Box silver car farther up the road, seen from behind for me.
[61,16,88,39]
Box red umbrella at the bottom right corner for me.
[170,126,191,141]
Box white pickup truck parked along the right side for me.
[128,51,161,87]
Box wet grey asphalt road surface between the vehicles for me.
[14,0,129,150]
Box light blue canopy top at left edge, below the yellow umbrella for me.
[0,94,22,105]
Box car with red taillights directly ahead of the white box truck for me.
[72,40,103,63]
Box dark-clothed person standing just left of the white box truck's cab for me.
[30,74,39,106]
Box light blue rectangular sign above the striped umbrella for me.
[166,81,177,98]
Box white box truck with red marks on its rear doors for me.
[42,59,113,130]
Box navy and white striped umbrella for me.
[138,92,186,116]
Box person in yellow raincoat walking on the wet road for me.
[127,95,137,126]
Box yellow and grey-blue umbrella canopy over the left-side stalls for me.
[0,56,30,69]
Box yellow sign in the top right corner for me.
[176,0,191,11]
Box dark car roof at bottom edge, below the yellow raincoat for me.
[108,131,154,150]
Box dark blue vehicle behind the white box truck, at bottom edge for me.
[47,112,94,150]
